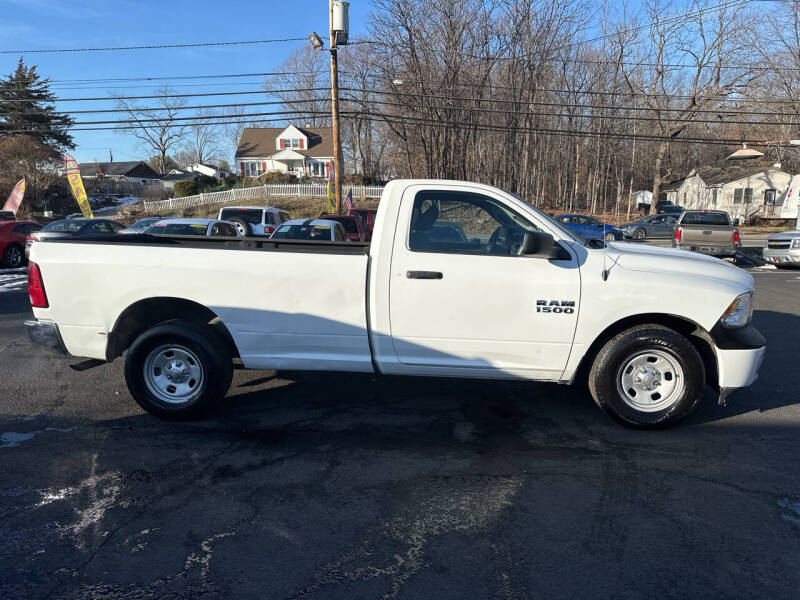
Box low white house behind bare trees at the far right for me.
[664,165,792,220]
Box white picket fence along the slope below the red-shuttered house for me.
[144,183,383,213]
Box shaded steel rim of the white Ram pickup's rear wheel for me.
[144,344,205,405]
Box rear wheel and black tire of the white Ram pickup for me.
[125,321,233,420]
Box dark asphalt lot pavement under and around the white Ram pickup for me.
[0,271,800,600]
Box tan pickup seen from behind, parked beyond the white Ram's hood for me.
[672,210,742,257]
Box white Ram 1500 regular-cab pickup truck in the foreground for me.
[21,180,765,428]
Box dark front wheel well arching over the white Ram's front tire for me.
[573,313,718,387]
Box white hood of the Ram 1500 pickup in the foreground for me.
[608,243,754,292]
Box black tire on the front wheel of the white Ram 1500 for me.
[589,324,706,429]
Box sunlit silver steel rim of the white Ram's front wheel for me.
[617,350,685,412]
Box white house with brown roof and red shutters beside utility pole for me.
[236,125,333,177]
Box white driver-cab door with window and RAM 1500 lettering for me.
[389,186,580,379]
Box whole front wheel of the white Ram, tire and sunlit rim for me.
[589,324,705,429]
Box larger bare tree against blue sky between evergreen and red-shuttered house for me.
[117,87,187,174]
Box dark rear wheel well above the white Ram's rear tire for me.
[106,298,239,362]
